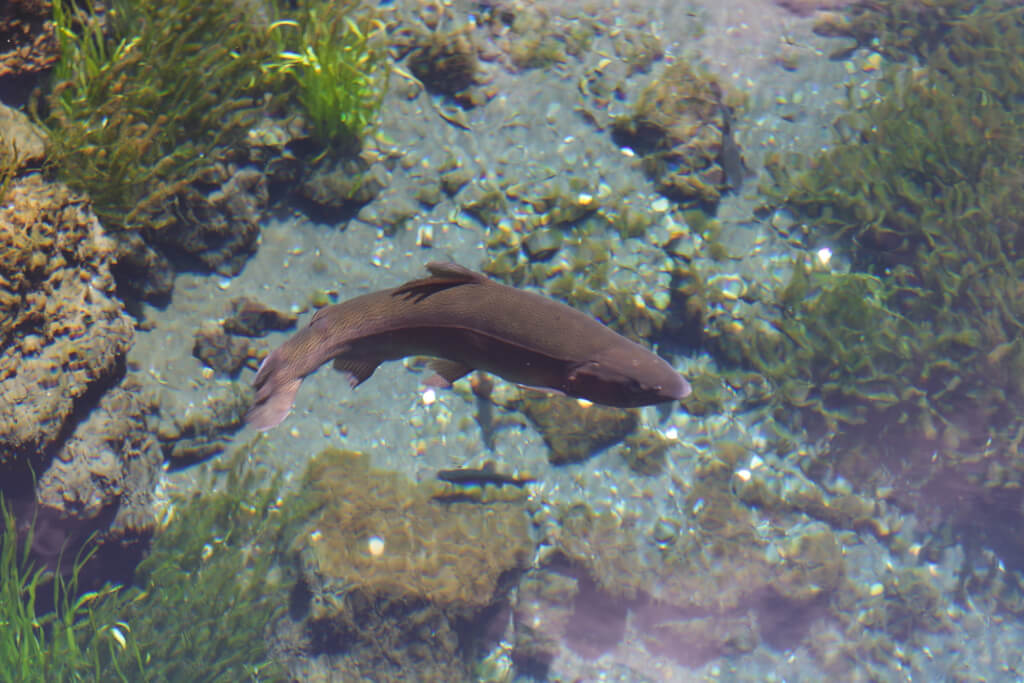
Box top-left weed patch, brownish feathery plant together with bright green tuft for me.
[43,0,388,233]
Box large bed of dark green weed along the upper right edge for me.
[753,3,1024,473]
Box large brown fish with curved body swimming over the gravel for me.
[245,262,690,431]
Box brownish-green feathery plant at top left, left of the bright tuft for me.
[44,0,269,231]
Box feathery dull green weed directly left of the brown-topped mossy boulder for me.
[115,447,309,681]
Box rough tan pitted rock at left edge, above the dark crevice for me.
[0,175,133,465]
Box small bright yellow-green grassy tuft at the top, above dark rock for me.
[263,0,390,154]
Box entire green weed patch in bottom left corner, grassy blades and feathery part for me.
[0,449,311,681]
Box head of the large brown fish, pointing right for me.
[565,342,690,408]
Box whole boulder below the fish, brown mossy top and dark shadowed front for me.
[300,450,534,681]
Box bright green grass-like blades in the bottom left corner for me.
[0,499,146,683]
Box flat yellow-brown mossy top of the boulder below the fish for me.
[302,451,534,617]
